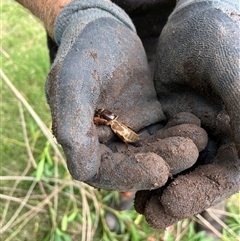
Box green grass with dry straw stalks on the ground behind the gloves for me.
[0,0,240,241]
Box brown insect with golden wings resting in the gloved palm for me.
[93,109,140,143]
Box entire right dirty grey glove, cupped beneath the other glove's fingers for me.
[135,0,240,228]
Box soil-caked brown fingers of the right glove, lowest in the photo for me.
[134,143,240,229]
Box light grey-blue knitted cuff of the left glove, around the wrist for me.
[54,0,136,45]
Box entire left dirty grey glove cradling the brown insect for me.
[46,0,207,191]
